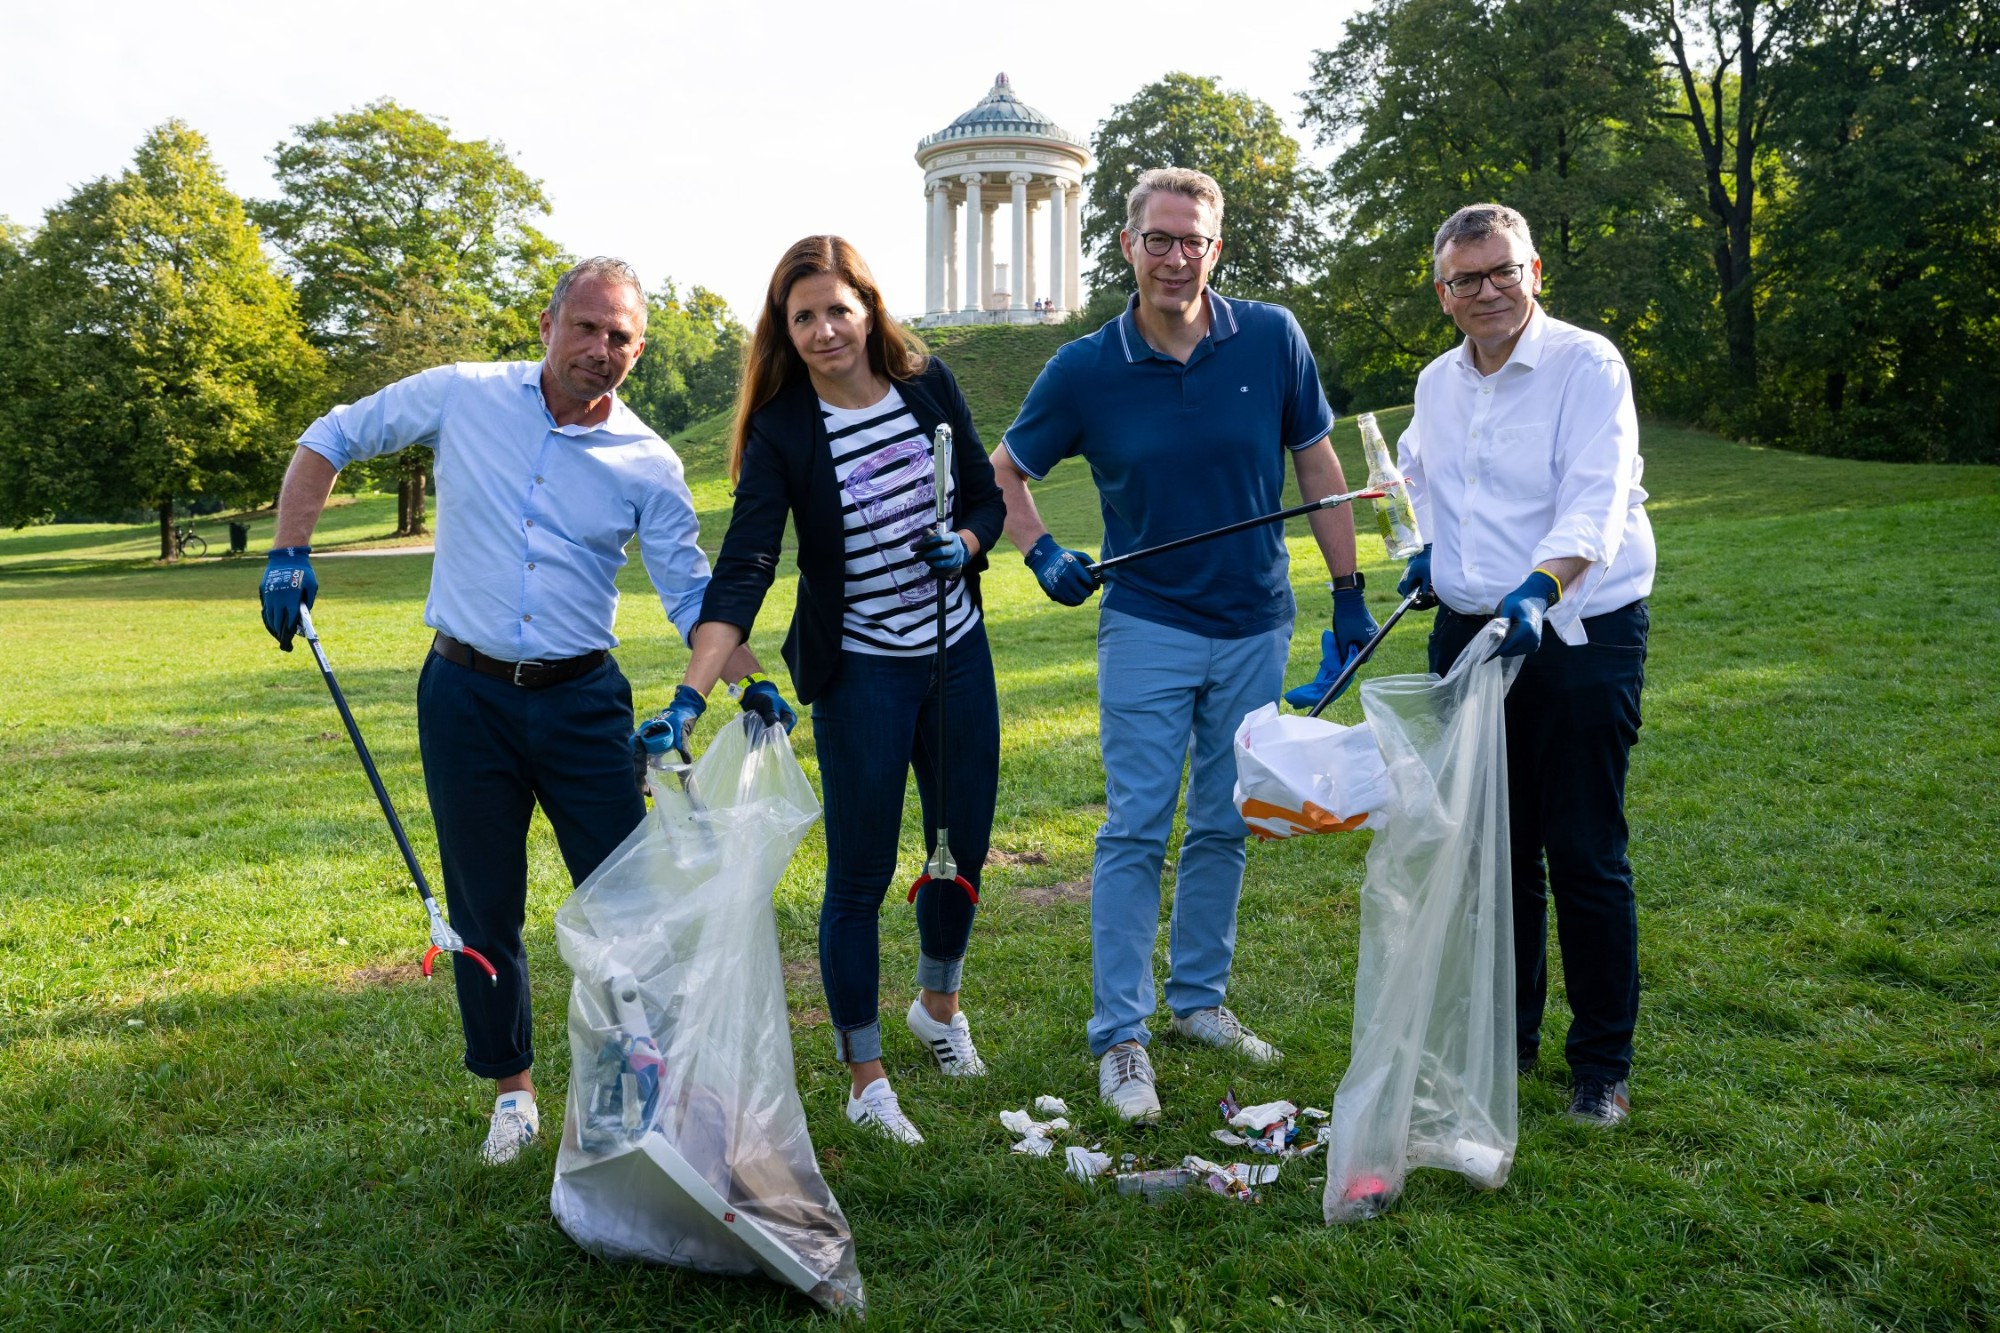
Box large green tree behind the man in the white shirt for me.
[1298,0,1708,402]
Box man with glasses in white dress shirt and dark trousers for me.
[1400,204,1654,1125]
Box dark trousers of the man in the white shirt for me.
[1430,602,1650,1079]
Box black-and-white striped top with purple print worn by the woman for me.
[820,384,980,656]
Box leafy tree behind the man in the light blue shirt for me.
[252,98,562,356]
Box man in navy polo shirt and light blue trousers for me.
[992,168,1376,1121]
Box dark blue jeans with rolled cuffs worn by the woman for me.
[812,620,1000,1065]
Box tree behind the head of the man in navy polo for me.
[1082,74,1320,298]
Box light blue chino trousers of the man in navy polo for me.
[1090,610,1292,1055]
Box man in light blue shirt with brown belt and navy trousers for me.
[262,258,782,1163]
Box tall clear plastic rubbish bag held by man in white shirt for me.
[1326,620,1520,1223]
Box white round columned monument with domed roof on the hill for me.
[916,74,1090,324]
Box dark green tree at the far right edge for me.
[1760,0,2000,462]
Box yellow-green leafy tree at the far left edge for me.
[0,120,322,558]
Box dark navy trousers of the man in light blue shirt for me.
[416,654,646,1079]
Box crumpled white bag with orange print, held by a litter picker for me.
[1236,703,1390,839]
